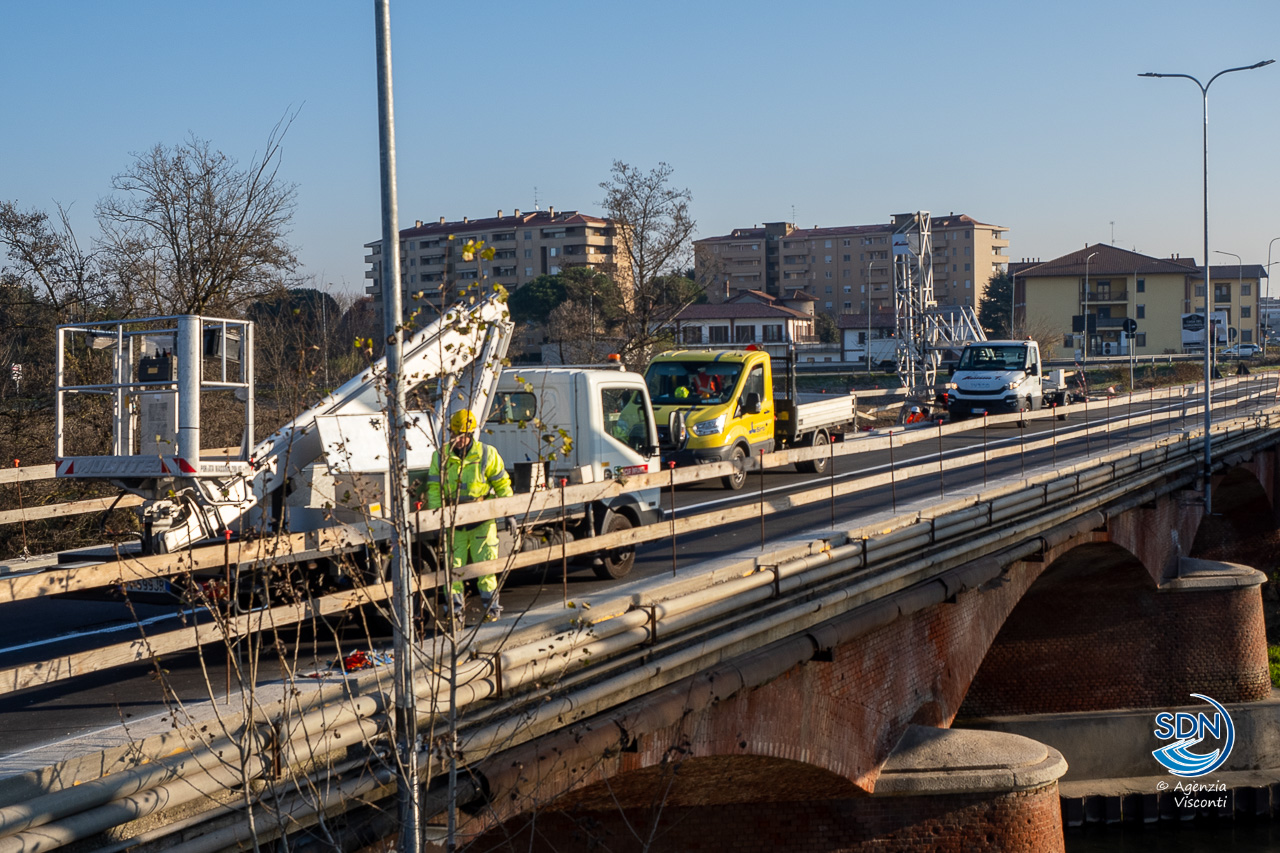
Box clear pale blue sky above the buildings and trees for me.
[0,0,1280,291]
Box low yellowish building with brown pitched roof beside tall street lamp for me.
[1011,243,1266,359]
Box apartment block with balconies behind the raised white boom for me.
[365,207,630,314]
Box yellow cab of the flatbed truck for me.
[645,350,774,489]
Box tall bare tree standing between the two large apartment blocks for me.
[600,160,696,362]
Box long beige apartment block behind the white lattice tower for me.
[694,214,1009,314]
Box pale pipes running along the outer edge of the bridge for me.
[0,389,1280,853]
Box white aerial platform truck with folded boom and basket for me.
[55,295,659,592]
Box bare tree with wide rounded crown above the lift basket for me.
[97,119,298,314]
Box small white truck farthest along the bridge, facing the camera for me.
[943,341,1066,421]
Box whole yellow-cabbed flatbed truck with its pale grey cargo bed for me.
[645,347,858,489]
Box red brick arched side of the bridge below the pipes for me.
[462,451,1280,852]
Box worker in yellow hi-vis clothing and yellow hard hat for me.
[426,409,513,624]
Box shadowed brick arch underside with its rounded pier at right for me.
[957,540,1271,717]
